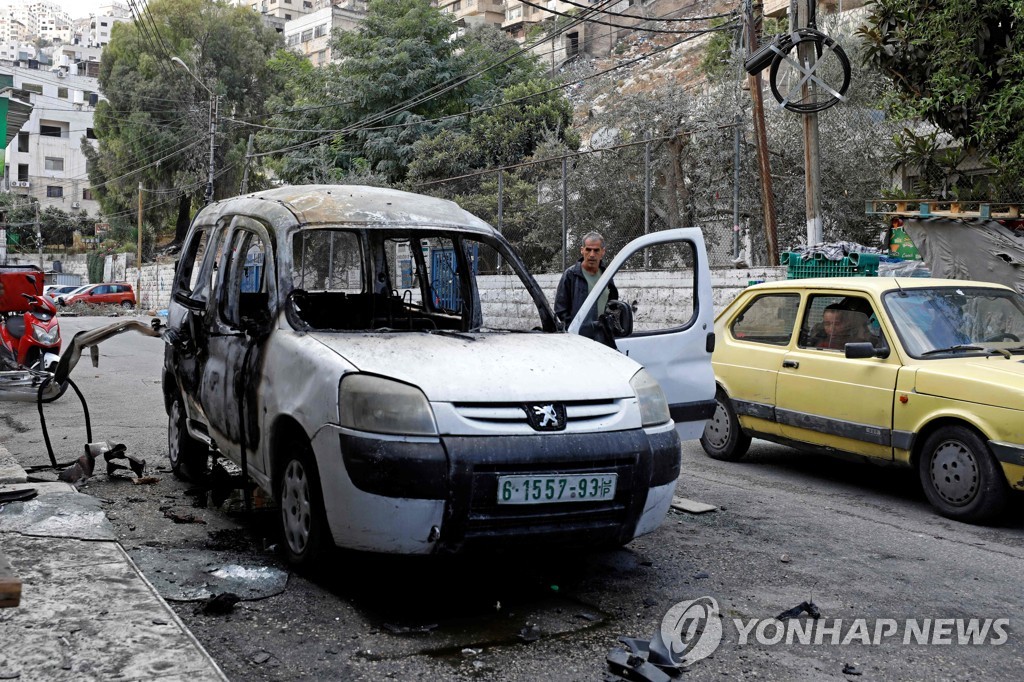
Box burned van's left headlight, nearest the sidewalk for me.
[338,374,437,435]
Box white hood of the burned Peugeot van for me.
[310,332,640,402]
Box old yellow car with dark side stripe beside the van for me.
[700,278,1024,522]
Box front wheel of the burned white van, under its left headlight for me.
[278,446,329,568]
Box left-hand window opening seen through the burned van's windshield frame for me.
[292,229,364,294]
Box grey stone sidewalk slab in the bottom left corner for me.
[0,444,227,682]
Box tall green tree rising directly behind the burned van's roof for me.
[260,0,465,182]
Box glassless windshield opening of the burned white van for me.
[289,228,550,333]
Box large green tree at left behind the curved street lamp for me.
[82,0,281,240]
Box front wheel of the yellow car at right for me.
[919,426,1010,523]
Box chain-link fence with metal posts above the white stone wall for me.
[416,95,893,272]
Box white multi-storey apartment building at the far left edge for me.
[0,65,99,213]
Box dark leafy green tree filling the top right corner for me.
[858,0,1024,188]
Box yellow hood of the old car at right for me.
[914,355,1024,410]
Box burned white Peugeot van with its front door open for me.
[164,185,715,565]
